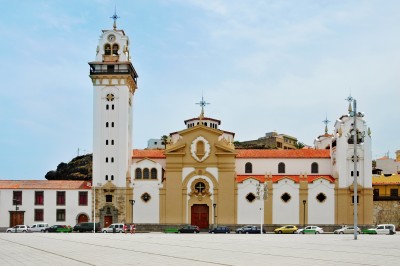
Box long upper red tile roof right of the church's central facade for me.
[236,149,331,159]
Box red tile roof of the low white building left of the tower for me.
[0,180,91,189]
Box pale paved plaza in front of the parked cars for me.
[0,233,400,266]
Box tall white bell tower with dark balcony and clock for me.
[89,13,138,226]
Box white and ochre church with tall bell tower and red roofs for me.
[89,19,373,231]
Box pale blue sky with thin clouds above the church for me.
[0,0,400,179]
